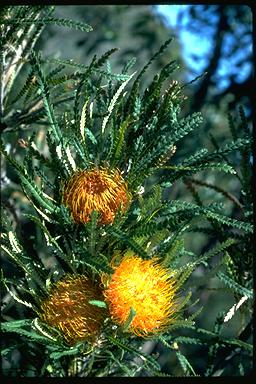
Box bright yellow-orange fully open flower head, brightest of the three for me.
[102,255,178,336]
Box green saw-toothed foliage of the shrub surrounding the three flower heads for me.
[1,6,253,377]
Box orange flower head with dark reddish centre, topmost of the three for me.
[63,168,130,224]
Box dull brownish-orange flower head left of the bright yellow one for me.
[39,275,106,345]
